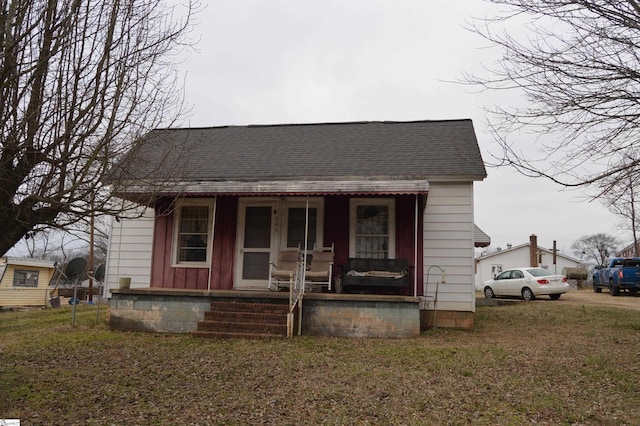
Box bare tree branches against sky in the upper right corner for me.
[464,0,640,195]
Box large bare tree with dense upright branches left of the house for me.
[0,0,196,253]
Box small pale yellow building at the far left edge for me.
[0,257,55,308]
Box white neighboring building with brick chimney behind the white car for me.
[476,235,582,289]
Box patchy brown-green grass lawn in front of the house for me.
[0,300,640,426]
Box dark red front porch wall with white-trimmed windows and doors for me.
[150,194,425,296]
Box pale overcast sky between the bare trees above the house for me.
[166,0,630,254]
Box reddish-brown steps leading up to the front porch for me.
[193,302,289,339]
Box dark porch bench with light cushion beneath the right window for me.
[336,258,412,293]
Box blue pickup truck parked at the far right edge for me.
[593,257,640,296]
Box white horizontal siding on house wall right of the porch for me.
[423,182,475,312]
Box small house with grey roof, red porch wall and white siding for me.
[105,120,486,334]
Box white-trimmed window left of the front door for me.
[173,200,214,266]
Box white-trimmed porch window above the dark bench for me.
[349,198,396,259]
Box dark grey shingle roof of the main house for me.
[128,120,486,181]
